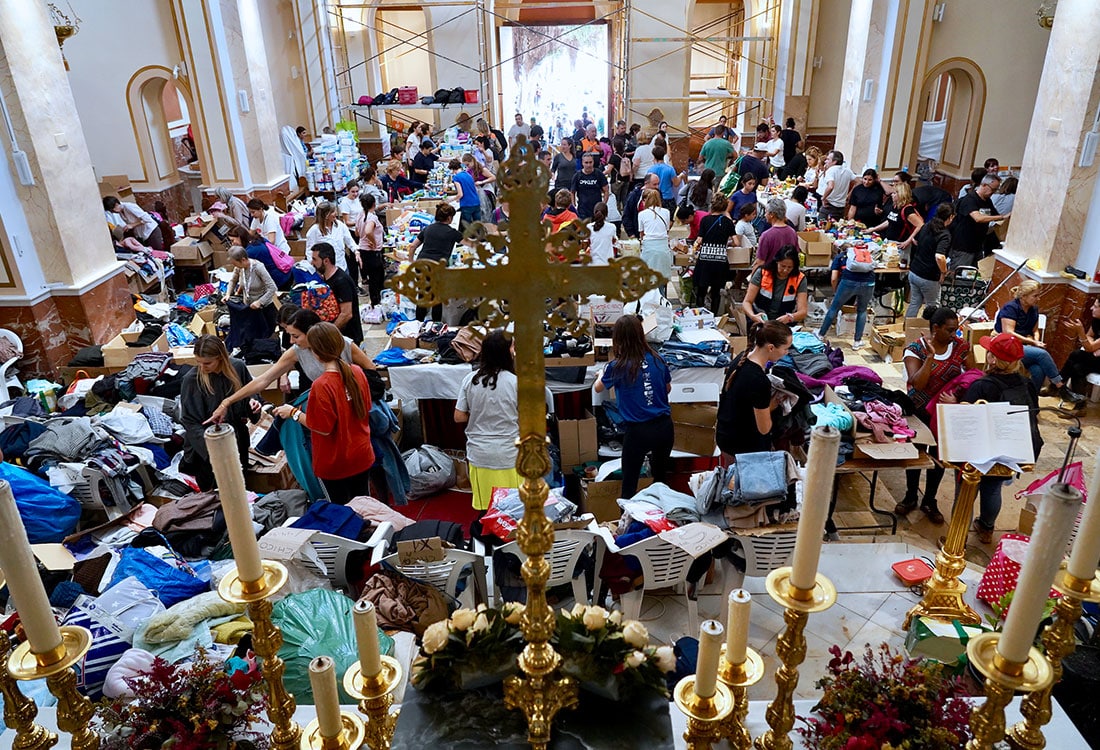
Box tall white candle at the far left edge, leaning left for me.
[0,479,62,655]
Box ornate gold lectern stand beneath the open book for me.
[902,462,1032,630]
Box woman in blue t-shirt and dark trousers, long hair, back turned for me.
[595,316,673,498]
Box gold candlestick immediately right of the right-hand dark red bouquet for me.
[966,632,1054,750]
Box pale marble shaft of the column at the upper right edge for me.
[1004,0,1100,277]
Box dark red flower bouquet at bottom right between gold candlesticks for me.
[798,643,970,750]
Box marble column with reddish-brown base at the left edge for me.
[0,2,133,377]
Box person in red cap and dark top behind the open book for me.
[965,333,1043,536]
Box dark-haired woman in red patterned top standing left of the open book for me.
[894,307,976,526]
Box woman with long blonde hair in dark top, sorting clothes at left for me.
[179,335,260,492]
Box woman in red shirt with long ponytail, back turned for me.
[275,322,374,505]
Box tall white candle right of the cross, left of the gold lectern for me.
[791,427,840,591]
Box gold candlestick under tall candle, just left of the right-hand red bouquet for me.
[754,566,836,750]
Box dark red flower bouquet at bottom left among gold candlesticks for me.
[97,649,267,750]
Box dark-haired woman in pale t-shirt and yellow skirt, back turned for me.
[454,331,523,510]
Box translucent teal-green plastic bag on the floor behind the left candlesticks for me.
[272,588,394,706]
